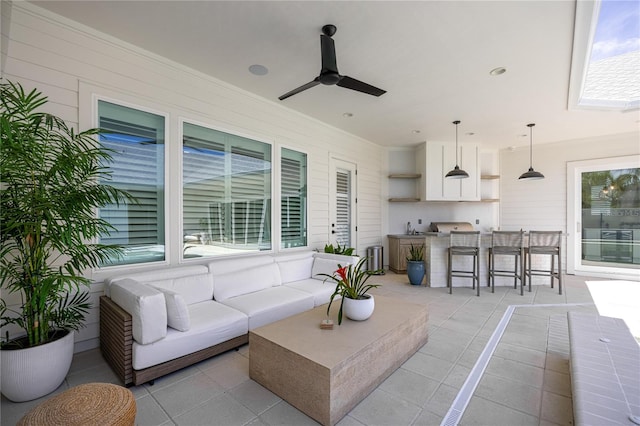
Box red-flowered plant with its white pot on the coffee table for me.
[320,257,380,325]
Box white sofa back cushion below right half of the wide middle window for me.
[213,263,281,302]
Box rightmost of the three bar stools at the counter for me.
[524,231,562,294]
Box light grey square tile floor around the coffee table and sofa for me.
[0,273,608,426]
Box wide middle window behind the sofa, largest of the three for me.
[182,123,271,258]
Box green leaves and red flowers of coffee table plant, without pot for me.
[319,257,380,325]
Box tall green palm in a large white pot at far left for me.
[0,81,133,401]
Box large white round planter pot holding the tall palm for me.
[0,331,74,402]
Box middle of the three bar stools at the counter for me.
[487,230,524,294]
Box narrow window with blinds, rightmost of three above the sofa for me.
[280,148,307,248]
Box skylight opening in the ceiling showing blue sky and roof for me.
[571,0,640,111]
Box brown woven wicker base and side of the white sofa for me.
[100,296,249,386]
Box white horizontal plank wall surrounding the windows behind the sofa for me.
[0,2,383,350]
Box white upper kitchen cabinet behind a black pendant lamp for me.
[416,142,480,201]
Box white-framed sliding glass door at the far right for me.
[567,156,640,276]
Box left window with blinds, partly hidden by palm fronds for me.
[98,101,165,266]
